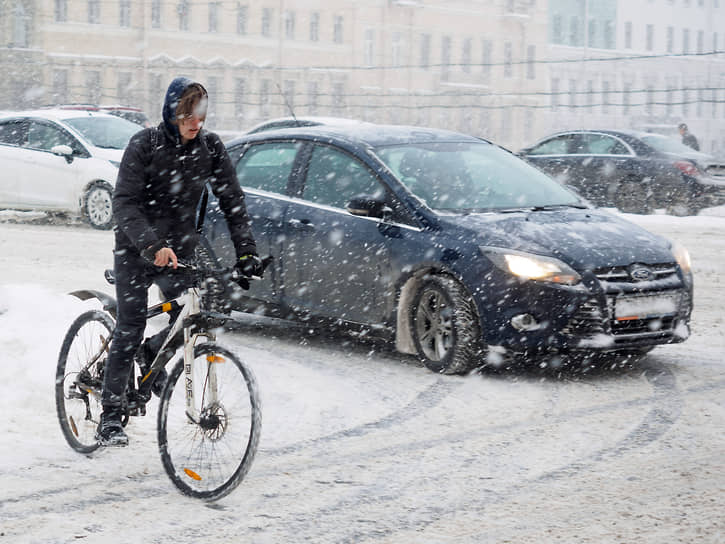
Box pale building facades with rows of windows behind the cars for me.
[0,0,725,151]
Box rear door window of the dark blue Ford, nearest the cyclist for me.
[237,142,301,194]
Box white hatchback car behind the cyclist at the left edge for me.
[0,109,140,229]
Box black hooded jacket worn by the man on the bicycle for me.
[113,77,256,258]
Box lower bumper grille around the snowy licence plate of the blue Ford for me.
[561,289,691,348]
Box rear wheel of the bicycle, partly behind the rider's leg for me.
[55,310,115,453]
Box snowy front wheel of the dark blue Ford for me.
[409,275,483,374]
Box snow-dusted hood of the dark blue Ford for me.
[443,209,674,271]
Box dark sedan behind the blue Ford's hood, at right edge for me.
[519,130,725,215]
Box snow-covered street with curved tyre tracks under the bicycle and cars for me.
[0,209,725,544]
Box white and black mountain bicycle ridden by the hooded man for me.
[55,251,271,501]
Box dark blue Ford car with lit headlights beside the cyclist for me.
[204,124,692,373]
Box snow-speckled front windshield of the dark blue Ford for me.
[376,142,581,211]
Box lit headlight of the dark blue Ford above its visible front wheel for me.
[481,246,581,285]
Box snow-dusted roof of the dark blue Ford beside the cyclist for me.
[227,123,485,147]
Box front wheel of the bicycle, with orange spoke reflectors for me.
[158,342,262,500]
